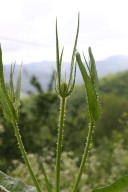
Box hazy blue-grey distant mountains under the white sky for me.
[4,55,128,91]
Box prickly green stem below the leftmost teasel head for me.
[13,122,41,192]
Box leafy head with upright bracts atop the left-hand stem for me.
[0,47,21,123]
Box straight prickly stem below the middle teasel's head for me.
[56,97,66,192]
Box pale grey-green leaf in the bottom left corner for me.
[0,171,36,192]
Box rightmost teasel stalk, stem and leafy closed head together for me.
[73,47,101,192]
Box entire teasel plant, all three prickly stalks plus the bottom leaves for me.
[0,14,128,192]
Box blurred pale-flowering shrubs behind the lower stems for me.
[8,118,128,192]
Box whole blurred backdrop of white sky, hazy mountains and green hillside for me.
[0,0,128,192]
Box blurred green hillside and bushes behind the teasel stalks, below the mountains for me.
[0,71,128,192]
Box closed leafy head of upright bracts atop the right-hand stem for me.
[76,48,101,122]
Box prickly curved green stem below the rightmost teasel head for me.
[73,122,94,192]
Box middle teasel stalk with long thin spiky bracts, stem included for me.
[55,14,80,192]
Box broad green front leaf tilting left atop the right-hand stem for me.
[76,50,101,121]
